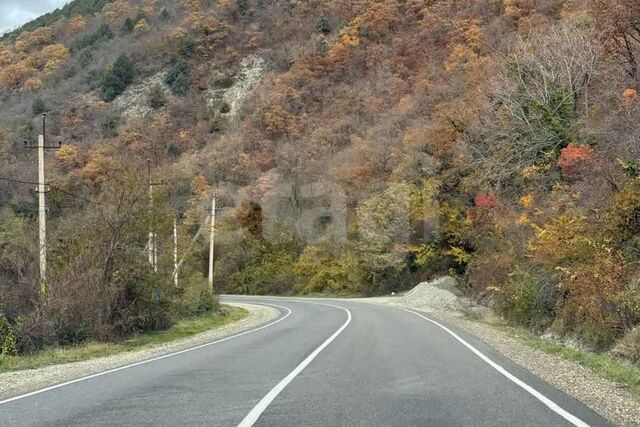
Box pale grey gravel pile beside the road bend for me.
[395,276,463,313]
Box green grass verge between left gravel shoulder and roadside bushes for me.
[0,306,248,373]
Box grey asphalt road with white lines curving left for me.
[0,297,610,426]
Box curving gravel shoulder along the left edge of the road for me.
[0,302,280,400]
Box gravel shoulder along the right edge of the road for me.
[362,297,640,426]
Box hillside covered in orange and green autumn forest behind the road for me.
[0,0,640,363]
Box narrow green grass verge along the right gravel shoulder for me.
[484,322,640,397]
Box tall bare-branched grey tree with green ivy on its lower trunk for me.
[472,24,601,186]
